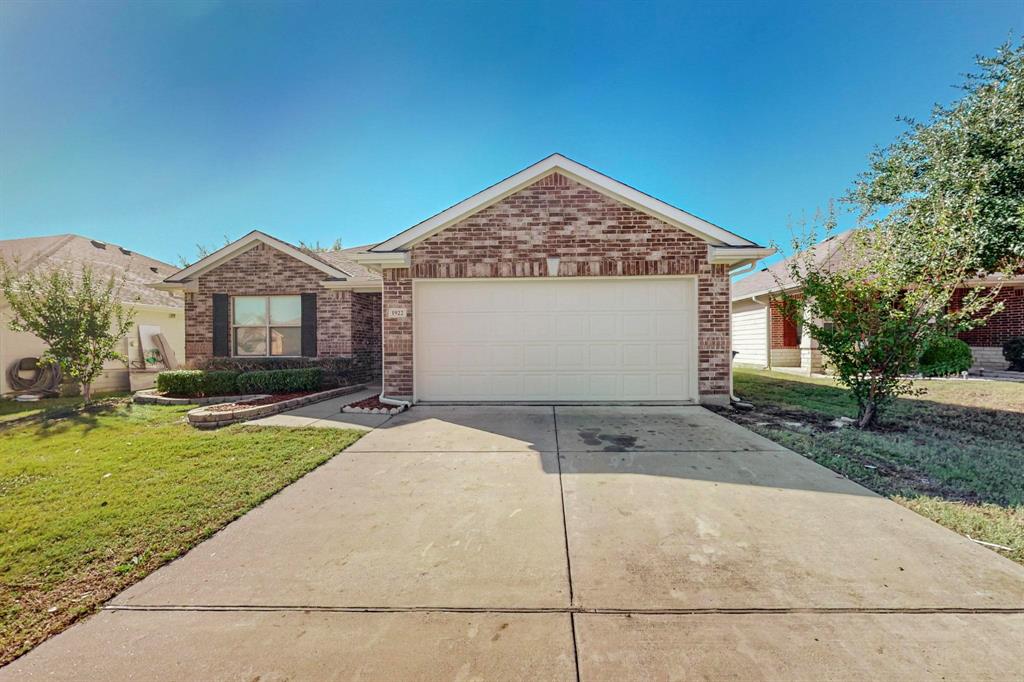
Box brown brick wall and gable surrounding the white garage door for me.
[362,155,764,403]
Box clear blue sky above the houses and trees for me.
[0,0,1024,262]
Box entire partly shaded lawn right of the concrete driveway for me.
[722,369,1024,563]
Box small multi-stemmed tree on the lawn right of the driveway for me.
[780,217,998,428]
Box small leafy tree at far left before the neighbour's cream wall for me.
[0,260,134,402]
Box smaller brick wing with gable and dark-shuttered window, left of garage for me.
[153,231,381,367]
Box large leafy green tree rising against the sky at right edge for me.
[849,42,1024,274]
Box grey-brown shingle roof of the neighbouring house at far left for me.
[0,235,184,308]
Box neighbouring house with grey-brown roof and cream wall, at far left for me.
[0,235,184,394]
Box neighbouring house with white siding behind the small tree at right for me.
[732,230,1024,374]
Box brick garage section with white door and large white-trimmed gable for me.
[356,155,773,404]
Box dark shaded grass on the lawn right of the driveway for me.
[720,376,1024,508]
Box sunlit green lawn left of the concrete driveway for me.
[0,400,359,665]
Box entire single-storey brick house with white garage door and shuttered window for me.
[161,155,771,403]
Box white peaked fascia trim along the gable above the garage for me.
[371,154,757,252]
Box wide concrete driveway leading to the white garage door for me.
[0,407,1024,681]
